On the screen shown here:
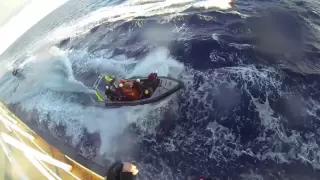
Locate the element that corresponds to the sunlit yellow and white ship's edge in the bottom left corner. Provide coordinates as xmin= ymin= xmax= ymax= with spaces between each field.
xmin=0 ymin=103 xmax=104 ymax=180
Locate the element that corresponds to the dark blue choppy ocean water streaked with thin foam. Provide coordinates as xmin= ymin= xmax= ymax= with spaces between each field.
xmin=1 ymin=0 xmax=320 ymax=180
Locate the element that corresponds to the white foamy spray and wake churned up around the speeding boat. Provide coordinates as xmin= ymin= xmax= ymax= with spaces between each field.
xmin=0 ymin=42 xmax=183 ymax=160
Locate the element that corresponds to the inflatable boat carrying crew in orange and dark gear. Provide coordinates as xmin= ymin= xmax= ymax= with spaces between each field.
xmin=93 ymin=73 xmax=184 ymax=107
